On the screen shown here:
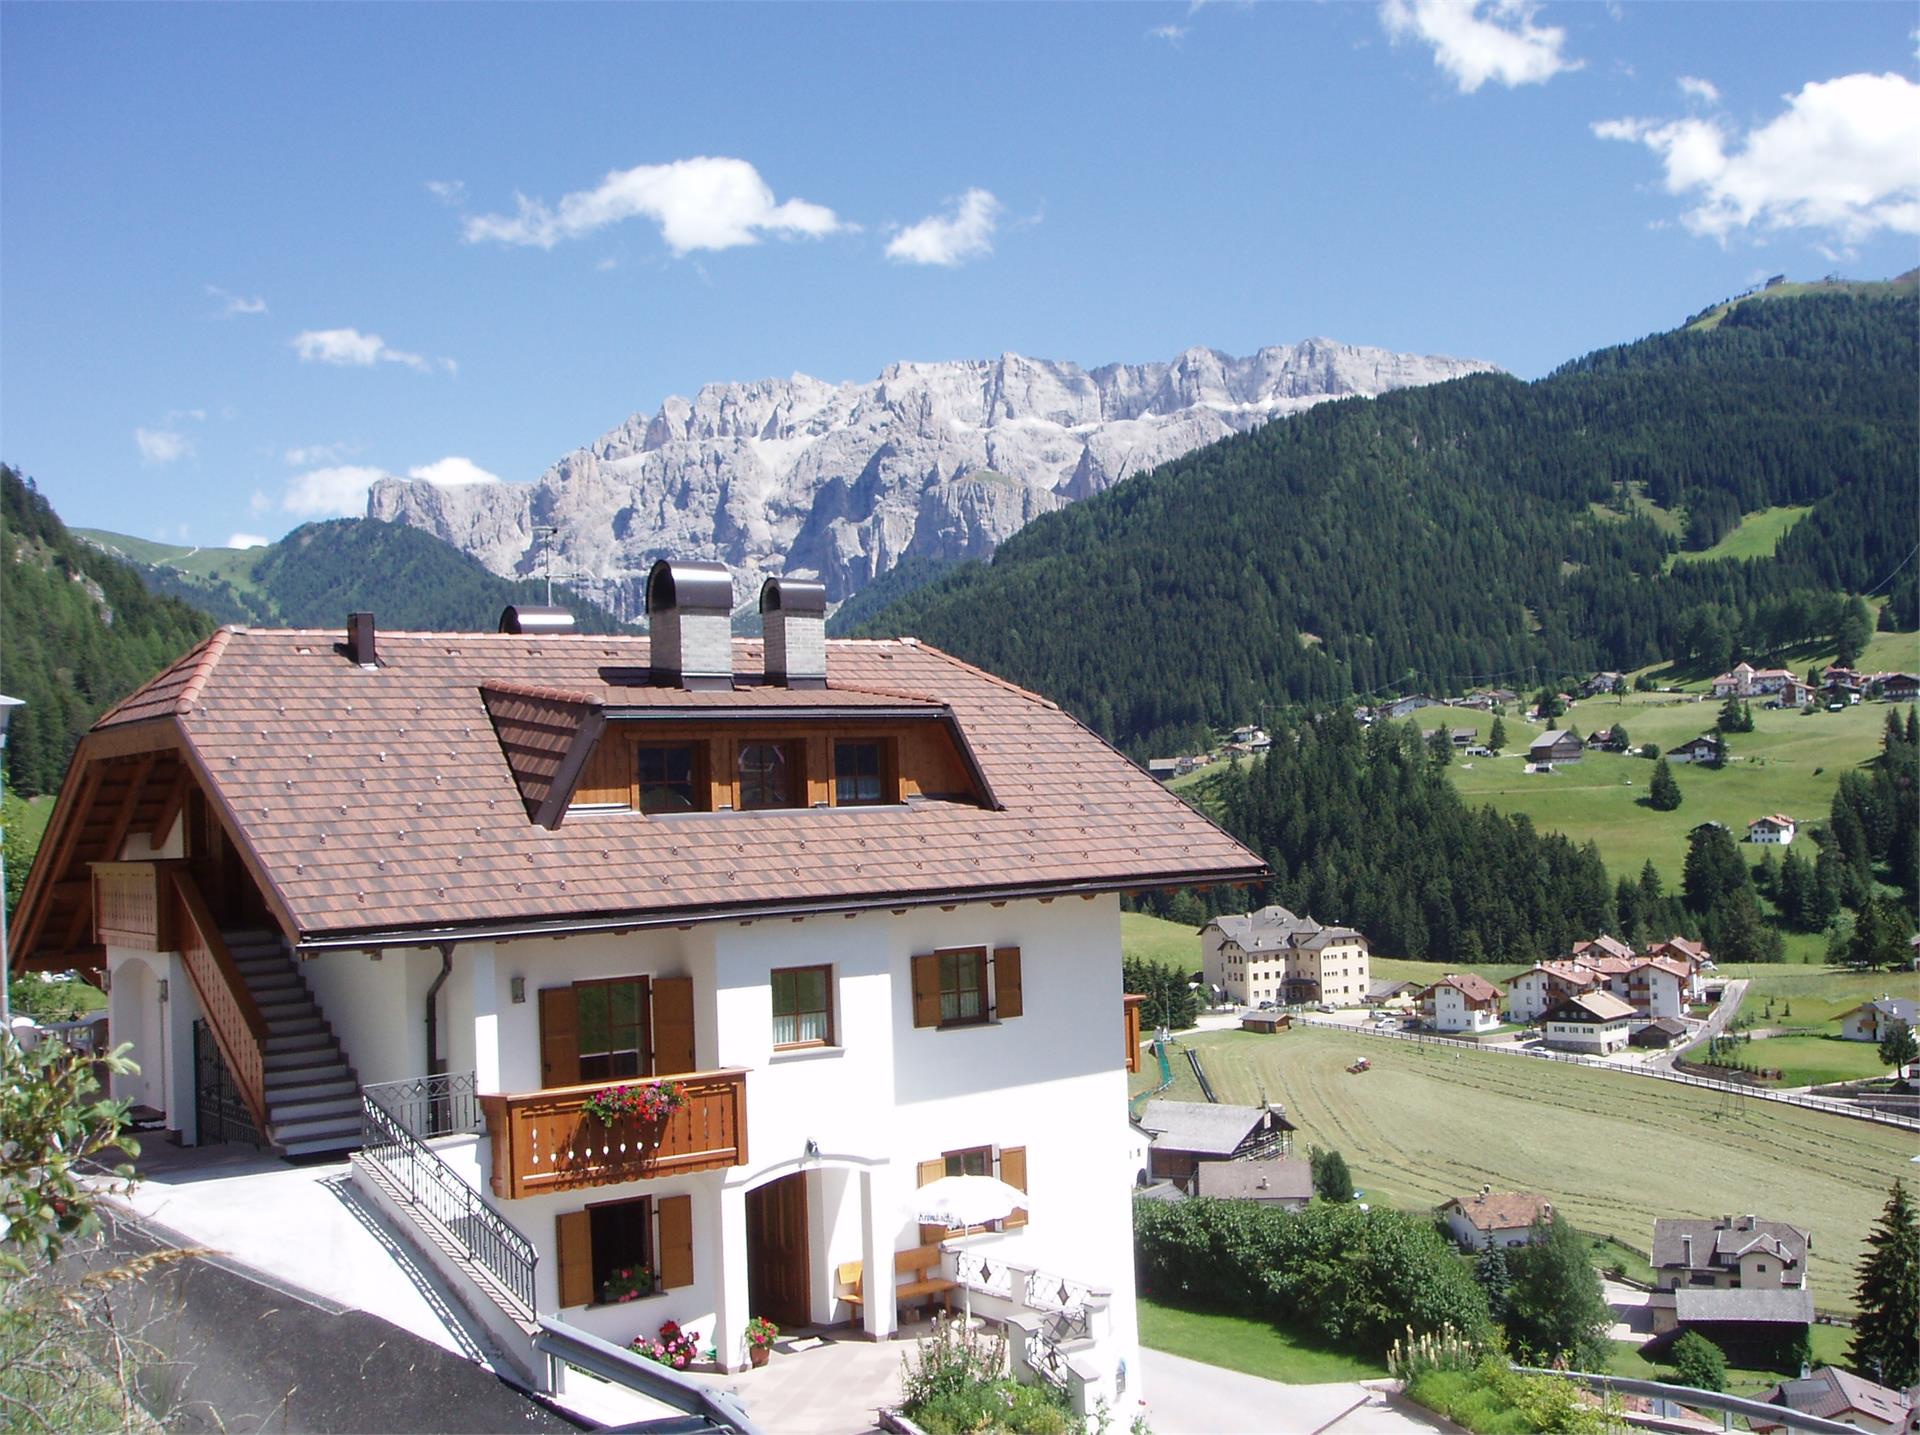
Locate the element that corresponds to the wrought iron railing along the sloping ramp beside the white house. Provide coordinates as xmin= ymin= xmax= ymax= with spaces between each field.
xmin=361 ymin=1074 xmax=538 ymax=1320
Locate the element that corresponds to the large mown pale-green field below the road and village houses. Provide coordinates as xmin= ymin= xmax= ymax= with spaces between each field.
xmin=1135 ymin=1028 xmax=1912 ymax=1310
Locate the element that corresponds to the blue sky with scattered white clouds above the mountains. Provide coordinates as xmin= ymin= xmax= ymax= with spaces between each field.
xmin=0 ymin=0 xmax=1920 ymax=544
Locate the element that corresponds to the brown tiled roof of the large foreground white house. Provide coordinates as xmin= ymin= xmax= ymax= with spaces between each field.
xmin=102 ymin=628 xmax=1263 ymax=941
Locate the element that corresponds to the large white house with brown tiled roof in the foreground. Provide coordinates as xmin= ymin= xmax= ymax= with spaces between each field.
xmin=15 ymin=561 xmax=1265 ymax=1406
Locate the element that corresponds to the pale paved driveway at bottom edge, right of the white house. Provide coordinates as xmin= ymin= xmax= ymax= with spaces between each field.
xmin=1136 ymin=1350 xmax=1457 ymax=1435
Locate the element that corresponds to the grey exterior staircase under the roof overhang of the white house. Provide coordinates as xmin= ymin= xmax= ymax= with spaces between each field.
xmin=223 ymin=930 xmax=361 ymax=1156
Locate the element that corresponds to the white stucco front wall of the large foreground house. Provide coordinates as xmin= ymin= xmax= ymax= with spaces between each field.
xmin=433 ymin=897 xmax=1139 ymax=1379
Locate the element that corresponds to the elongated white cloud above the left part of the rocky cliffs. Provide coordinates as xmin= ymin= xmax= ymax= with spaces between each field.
xmin=465 ymin=156 xmax=852 ymax=254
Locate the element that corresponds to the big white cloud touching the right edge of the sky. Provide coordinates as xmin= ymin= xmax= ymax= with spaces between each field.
xmin=1594 ymin=73 xmax=1920 ymax=244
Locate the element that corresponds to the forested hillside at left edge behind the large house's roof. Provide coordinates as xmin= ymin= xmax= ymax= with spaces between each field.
xmin=0 ymin=467 xmax=213 ymax=793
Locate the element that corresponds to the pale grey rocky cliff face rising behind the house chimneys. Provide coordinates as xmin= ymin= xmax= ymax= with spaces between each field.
xmin=367 ymin=347 xmax=1494 ymax=617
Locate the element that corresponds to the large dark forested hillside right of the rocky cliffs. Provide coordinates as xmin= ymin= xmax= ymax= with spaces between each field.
xmin=860 ymin=284 xmax=1920 ymax=755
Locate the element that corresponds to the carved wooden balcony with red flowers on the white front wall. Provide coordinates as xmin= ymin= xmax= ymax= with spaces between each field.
xmin=480 ymin=1070 xmax=747 ymax=1201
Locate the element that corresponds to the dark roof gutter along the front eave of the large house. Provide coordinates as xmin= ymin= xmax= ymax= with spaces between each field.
xmin=294 ymin=866 xmax=1273 ymax=957
